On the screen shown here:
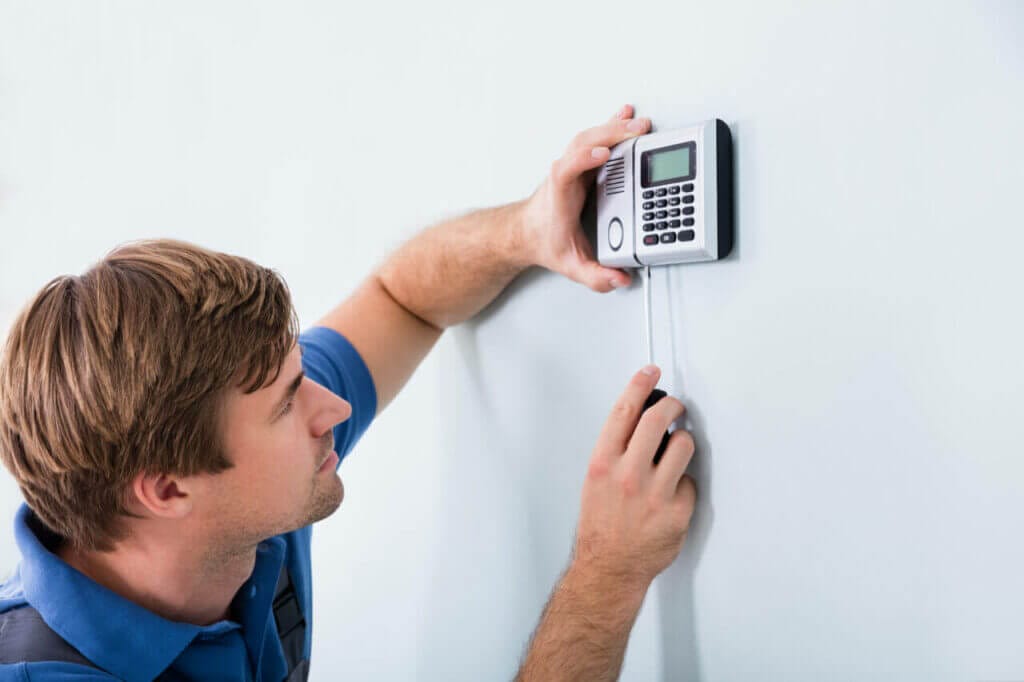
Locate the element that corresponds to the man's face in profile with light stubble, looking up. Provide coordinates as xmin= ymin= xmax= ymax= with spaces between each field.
xmin=203 ymin=345 xmax=352 ymax=545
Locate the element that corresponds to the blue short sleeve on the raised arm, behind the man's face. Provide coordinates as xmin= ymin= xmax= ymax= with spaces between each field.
xmin=299 ymin=327 xmax=377 ymax=464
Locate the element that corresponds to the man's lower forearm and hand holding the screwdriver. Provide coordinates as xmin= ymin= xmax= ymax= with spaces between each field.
xmin=516 ymin=367 xmax=696 ymax=682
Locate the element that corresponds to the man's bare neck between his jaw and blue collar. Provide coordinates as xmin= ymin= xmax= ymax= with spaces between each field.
xmin=57 ymin=522 xmax=256 ymax=626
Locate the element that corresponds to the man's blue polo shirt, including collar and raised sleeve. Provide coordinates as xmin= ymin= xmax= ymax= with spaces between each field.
xmin=0 ymin=327 xmax=377 ymax=682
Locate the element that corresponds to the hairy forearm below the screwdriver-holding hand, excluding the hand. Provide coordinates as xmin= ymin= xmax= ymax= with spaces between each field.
xmin=516 ymin=565 xmax=646 ymax=682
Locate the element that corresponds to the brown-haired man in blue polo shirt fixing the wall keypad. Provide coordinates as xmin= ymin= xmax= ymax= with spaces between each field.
xmin=0 ymin=105 xmax=695 ymax=681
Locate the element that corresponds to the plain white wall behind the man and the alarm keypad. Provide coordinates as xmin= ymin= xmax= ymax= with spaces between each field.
xmin=0 ymin=1 xmax=1024 ymax=680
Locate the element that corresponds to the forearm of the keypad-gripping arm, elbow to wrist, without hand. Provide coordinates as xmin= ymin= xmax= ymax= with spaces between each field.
xmin=377 ymin=197 xmax=531 ymax=329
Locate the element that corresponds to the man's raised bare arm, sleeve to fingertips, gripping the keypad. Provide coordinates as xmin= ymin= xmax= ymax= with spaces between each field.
xmin=318 ymin=105 xmax=650 ymax=412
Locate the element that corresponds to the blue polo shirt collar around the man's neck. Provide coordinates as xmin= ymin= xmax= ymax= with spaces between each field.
xmin=14 ymin=504 xmax=285 ymax=682
